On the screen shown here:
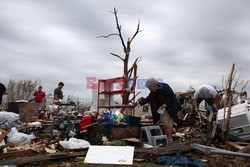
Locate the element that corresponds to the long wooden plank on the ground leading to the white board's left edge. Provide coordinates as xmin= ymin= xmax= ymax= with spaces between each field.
xmin=0 ymin=151 xmax=87 ymax=166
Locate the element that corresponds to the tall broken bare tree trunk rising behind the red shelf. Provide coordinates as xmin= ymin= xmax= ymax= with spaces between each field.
xmin=99 ymin=8 xmax=142 ymax=104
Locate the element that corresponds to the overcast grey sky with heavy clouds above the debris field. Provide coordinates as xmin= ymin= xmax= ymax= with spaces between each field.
xmin=0 ymin=0 xmax=250 ymax=99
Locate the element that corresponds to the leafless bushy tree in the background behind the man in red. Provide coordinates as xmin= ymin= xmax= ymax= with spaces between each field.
xmin=7 ymin=79 xmax=41 ymax=102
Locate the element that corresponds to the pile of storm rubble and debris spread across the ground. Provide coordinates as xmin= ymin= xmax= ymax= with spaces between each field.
xmin=0 ymin=99 xmax=250 ymax=166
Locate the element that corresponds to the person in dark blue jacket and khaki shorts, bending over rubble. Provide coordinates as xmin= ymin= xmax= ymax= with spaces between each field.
xmin=139 ymin=78 xmax=181 ymax=142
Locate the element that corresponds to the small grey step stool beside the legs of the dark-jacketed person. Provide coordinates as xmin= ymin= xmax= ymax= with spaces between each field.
xmin=141 ymin=125 xmax=168 ymax=146
